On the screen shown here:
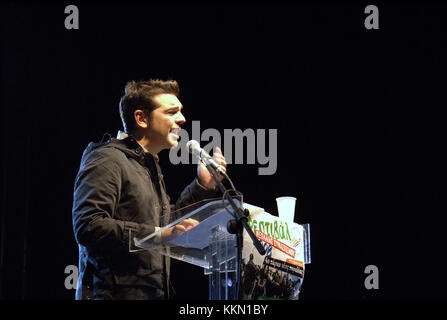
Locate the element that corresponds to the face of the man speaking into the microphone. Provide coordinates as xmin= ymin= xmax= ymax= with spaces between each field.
xmin=147 ymin=94 xmax=186 ymax=151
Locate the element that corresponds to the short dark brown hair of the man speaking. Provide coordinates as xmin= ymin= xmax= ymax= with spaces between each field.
xmin=119 ymin=79 xmax=180 ymax=134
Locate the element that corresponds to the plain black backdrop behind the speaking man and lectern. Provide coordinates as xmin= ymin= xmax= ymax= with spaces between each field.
xmin=0 ymin=1 xmax=447 ymax=300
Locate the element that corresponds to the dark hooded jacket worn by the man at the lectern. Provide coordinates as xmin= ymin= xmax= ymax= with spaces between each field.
xmin=72 ymin=135 xmax=215 ymax=299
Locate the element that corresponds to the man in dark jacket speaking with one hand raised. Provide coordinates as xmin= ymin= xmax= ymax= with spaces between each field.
xmin=72 ymin=79 xmax=226 ymax=300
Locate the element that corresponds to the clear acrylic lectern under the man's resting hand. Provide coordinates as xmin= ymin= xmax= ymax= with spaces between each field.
xmin=131 ymin=198 xmax=240 ymax=300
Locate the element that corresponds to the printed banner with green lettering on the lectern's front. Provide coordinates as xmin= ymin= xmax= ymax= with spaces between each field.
xmin=239 ymin=204 xmax=306 ymax=300
